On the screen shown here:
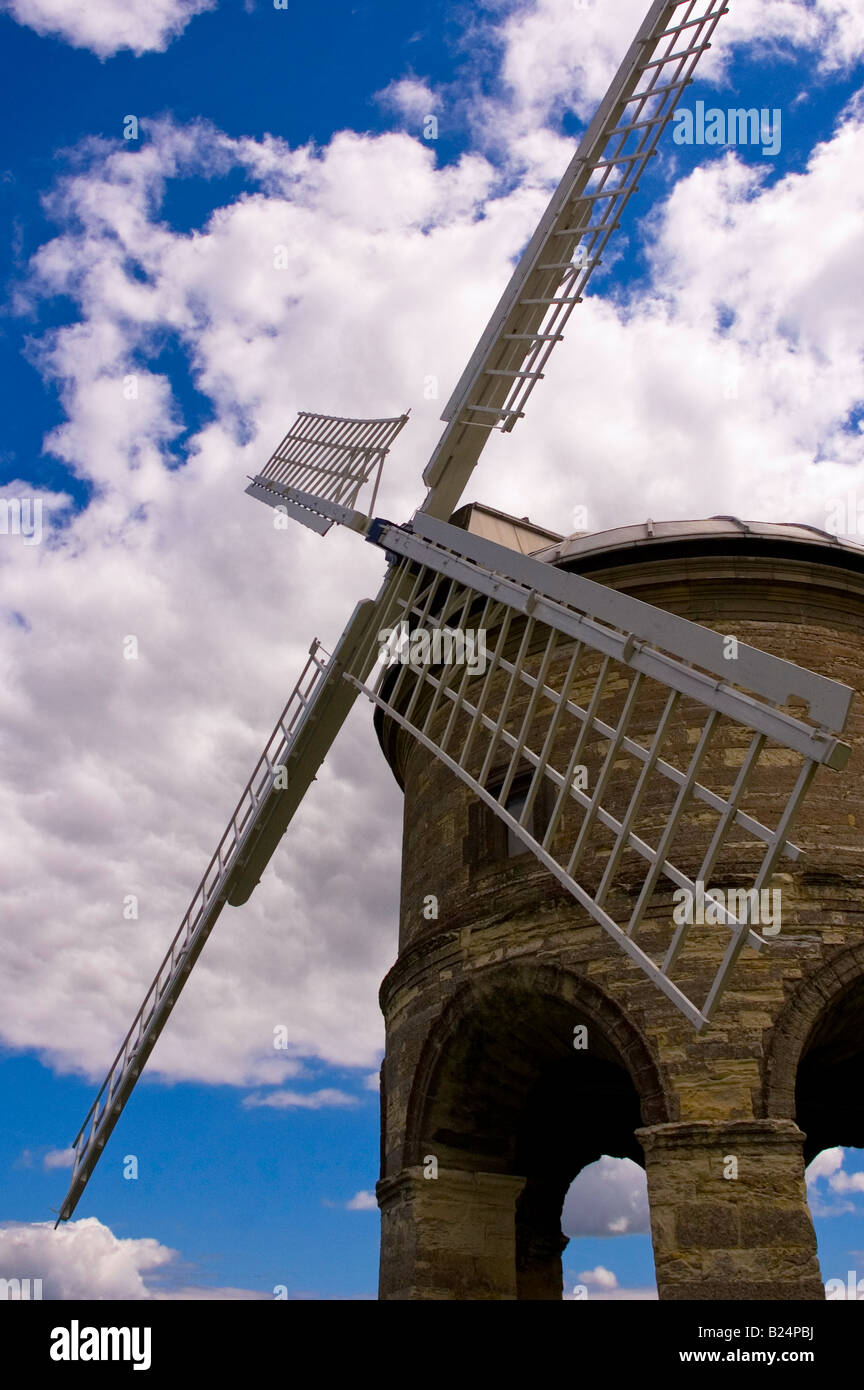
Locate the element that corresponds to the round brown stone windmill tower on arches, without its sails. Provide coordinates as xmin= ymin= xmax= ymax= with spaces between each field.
xmin=378 ymin=507 xmax=864 ymax=1300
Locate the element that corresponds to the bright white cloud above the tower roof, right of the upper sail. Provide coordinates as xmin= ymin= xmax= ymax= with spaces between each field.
xmin=488 ymin=92 xmax=864 ymax=530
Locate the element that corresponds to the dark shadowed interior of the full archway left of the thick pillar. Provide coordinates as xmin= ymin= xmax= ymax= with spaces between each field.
xmin=404 ymin=962 xmax=676 ymax=1298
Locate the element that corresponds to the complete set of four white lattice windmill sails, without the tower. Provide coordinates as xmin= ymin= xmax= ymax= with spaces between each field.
xmin=58 ymin=0 xmax=851 ymax=1222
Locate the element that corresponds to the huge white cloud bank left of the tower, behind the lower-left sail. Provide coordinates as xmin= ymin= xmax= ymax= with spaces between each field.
xmin=0 ymin=113 xmax=513 ymax=1106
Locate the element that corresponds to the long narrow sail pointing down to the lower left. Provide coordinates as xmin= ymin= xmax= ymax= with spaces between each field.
xmin=58 ymin=599 xmax=378 ymax=1222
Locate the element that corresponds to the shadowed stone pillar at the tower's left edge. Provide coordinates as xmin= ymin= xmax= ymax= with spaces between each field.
xmin=376 ymin=1166 xmax=525 ymax=1300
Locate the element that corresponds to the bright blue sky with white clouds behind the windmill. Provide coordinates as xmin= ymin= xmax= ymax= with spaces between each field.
xmin=0 ymin=0 xmax=864 ymax=1298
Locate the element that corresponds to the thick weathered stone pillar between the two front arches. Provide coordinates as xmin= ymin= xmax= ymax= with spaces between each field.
xmin=636 ymin=1120 xmax=825 ymax=1301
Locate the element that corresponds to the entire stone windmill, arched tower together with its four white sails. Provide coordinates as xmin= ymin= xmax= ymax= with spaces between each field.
xmin=60 ymin=0 xmax=864 ymax=1300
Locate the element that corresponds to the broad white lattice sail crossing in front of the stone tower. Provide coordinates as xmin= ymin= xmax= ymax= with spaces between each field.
xmin=347 ymin=514 xmax=851 ymax=1029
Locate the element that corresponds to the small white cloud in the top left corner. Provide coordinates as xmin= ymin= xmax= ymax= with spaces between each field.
xmin=1 ymin=0 xmax=217 ymax=58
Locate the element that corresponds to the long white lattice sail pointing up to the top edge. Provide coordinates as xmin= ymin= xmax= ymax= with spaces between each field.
xmin=422 ymin=0 xmax=728 ymax=520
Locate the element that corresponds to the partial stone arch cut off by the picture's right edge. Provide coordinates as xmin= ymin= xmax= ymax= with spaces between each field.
xmin=763 ymin=942 xmax=864 ymax=1162
